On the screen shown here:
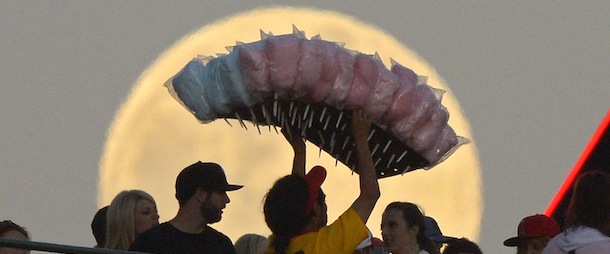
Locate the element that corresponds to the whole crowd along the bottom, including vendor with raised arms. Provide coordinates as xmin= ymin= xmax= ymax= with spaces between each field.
xmin=0 ymin=110 xmax=610 ymax=254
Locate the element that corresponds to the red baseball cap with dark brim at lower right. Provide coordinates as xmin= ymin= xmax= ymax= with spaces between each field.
xmin=504 ymin=214 xmax=561 ymax=247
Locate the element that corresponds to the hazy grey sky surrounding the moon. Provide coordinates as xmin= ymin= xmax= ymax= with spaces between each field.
xmin=0 ymin=1 xmax=610 ymax=253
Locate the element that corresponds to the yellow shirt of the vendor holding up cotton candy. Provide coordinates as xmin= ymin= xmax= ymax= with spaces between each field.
xmin=267 ymin=208 xmax=368 ymax=254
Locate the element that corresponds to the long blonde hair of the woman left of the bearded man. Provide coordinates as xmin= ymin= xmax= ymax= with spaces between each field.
xmin=104 ymin=190 xmax=155 ymax=250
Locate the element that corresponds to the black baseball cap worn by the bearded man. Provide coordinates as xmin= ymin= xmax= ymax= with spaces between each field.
xmin=176 ymin=161 xmax=244 ymax=201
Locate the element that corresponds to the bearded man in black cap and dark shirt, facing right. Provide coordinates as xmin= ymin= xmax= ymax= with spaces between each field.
xmin=129 ymin=161 xmax=243 ymax=254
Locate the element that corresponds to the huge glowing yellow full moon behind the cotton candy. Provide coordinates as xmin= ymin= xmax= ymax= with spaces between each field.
xmin=98 ymin=7 xmax=483 ymax=241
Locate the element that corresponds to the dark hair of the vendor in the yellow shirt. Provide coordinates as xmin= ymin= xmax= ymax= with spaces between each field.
xmin=263 ymin=175 xmax=324 ymax=254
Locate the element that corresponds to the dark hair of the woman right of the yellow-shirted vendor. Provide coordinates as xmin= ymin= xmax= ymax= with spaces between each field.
xmin=384 ymin=202 xmax=439 ymax=254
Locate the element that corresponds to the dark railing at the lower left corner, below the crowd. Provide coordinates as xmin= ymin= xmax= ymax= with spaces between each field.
xmin=0 ymin=237 xmax=143 ymax=254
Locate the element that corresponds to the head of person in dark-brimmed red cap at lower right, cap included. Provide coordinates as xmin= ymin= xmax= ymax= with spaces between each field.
xmin=504 ymin=214 xmax=560 ymax=254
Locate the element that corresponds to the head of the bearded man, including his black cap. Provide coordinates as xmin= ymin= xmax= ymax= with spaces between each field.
xmin=176 ymin=161 xmax=243 ymax=224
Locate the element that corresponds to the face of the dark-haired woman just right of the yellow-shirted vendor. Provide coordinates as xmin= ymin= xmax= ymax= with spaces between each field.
xmin=381 ymin=209 xmax=419 ymax=253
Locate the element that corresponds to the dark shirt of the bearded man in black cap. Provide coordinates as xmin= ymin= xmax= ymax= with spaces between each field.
xmin=129 ymin=222 xmax=236 ymax=254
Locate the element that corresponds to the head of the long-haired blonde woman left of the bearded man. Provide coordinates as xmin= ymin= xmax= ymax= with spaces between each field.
xmin=104 ymin=190 xmax=159 ymax=250
